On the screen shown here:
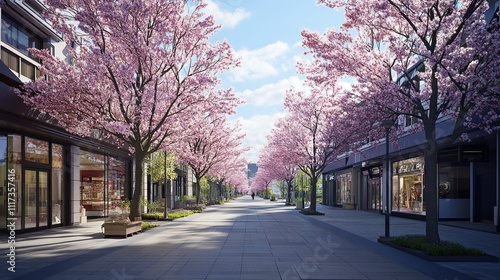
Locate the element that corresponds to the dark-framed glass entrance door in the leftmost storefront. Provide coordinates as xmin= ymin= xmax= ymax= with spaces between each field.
xmin=24 ymin=170 xmax=50 ymax=228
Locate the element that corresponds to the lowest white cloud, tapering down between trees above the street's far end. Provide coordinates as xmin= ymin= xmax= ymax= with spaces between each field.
xmin=231 ymin=113 xmax=283 ymax=162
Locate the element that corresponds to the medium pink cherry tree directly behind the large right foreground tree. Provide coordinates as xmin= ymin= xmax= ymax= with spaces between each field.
xmin=281 ymin=88 xmax=366 ymax=211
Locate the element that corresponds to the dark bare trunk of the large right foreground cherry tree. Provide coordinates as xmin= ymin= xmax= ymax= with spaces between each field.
xmin=424 ymin=137 xmax=440 ymax=243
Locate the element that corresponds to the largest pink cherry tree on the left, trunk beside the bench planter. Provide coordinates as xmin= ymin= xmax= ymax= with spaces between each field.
xmin=17 ymin=0 xmax=238 ymax=220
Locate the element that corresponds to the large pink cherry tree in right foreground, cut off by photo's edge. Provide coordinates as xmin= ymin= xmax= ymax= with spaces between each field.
xmin=299 ymin=0 xmax=500 ymax=242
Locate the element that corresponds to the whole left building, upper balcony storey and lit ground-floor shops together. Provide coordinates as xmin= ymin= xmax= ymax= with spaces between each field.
xmin=0 ymin=0 xmax=139 ymax=232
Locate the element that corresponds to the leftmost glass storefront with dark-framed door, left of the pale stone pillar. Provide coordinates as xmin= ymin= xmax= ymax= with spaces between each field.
xmin=0 ymin=134 xmax=66 ymax=230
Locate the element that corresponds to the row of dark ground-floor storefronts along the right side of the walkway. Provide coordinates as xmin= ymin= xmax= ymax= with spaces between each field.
xmin=323 ymin=119 xmax=500 ymax=229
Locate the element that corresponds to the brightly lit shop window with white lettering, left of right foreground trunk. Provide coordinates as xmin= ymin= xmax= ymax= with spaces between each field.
xmin=392 ymin=157 xmax=425 ymax=215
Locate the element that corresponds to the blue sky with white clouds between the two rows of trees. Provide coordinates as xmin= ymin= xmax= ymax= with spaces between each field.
xmin=201 ymin=0 xmax=344 ymax=163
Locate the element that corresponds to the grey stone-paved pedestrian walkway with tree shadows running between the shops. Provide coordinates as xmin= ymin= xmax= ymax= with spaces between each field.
xmin=0 ymin=196 xmax=500 ymax=280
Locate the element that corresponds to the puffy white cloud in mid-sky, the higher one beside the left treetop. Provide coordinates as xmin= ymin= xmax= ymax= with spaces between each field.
xmin=227 ymin=41 xmax=290 ymax=82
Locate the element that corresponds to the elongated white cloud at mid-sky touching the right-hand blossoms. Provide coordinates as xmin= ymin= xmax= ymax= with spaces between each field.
xmin=236 ymin=76 xmax=303 ymax=106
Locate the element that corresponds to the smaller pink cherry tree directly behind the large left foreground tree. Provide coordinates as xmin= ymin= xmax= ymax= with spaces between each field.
xmin=176 ymin=114 xmax=245 ymax=204
